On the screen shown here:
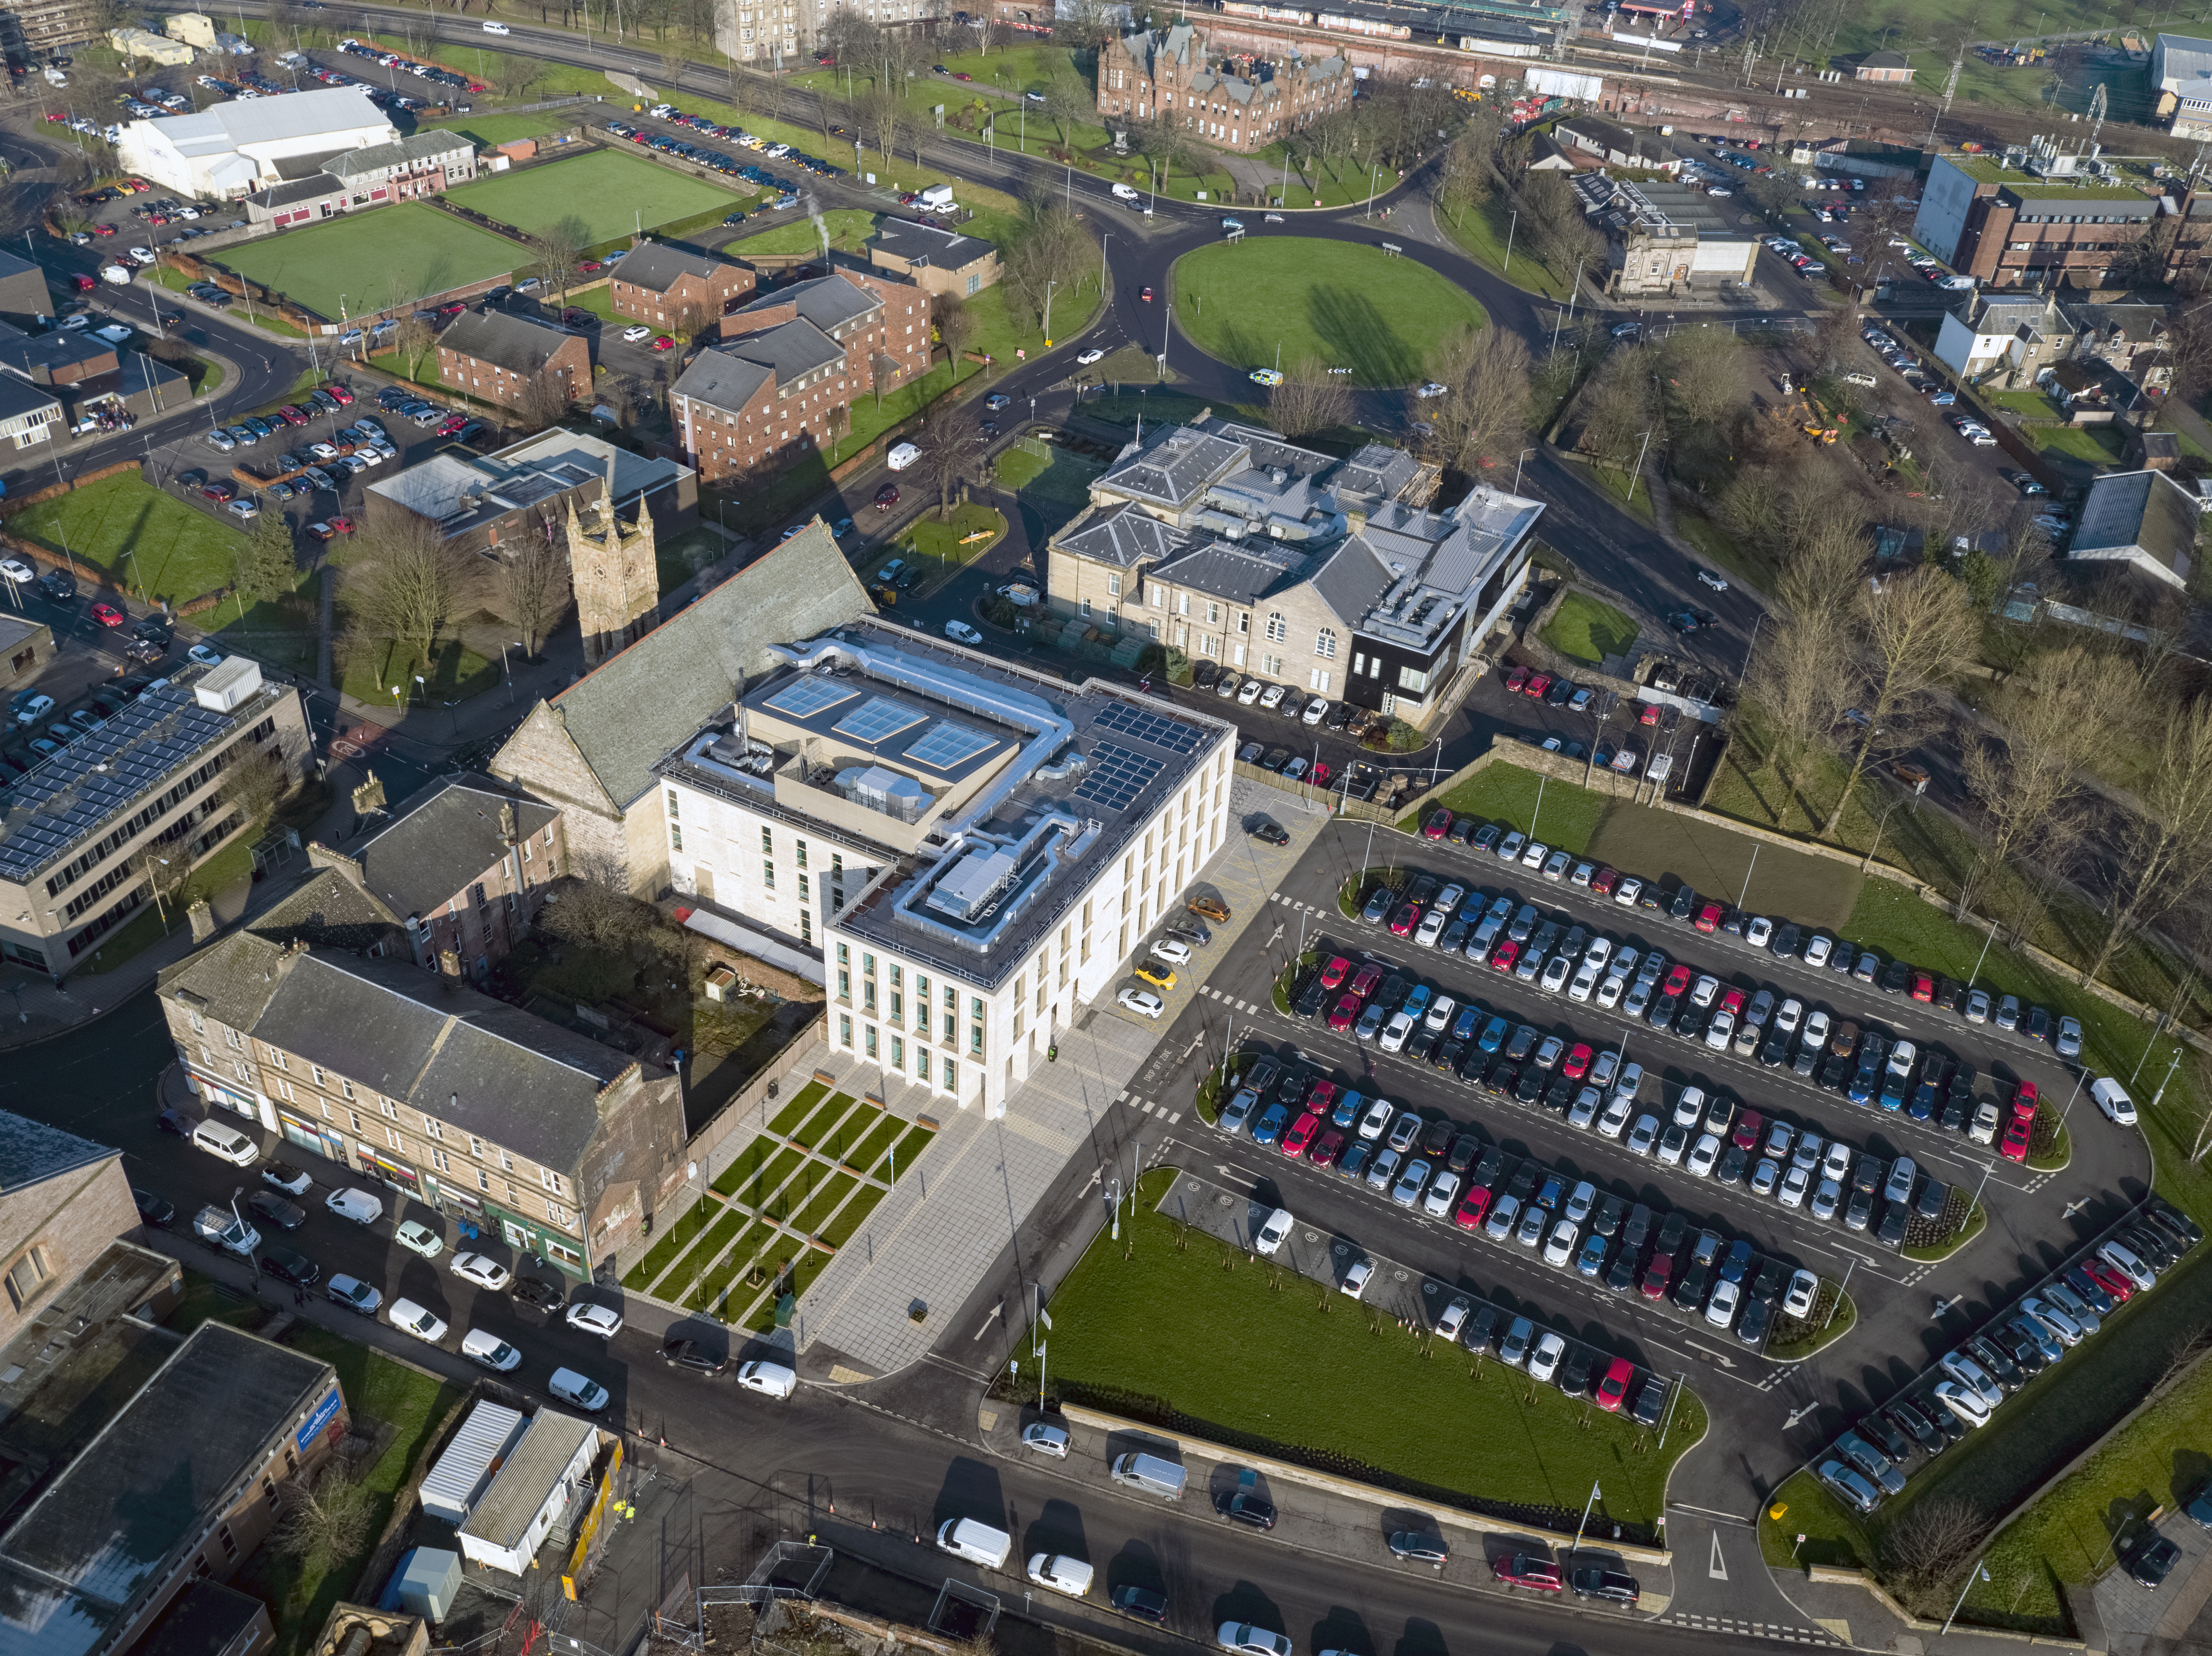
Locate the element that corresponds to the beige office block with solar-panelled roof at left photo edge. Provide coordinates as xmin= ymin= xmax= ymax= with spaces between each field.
xmin=0 ymin=656 xmax=312 ymax=975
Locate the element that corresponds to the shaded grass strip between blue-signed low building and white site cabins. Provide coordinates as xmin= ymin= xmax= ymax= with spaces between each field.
xmin=232 ymin=1324 xmax=467 ymax=1651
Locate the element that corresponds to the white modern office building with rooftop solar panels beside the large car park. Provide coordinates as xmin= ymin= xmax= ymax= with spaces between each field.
xmin=655 ymin=617 xmax=1236 ymax=1117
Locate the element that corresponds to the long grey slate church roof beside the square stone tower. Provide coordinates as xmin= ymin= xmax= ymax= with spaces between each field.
xmin=526 ymin=517 xmax=874 ymax=807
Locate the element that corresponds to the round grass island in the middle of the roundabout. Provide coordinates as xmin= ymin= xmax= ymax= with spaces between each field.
xmin=1174 ymin=239 xmax=1484 ymax=385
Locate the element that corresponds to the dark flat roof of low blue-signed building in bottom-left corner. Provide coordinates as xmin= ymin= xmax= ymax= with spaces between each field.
xmin=0 ymin=1322 xmax=339 ymax=1656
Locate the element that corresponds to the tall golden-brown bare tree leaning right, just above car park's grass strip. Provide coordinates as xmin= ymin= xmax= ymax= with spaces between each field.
xmin=1821 ymin=568 xmax=1982 ymax=838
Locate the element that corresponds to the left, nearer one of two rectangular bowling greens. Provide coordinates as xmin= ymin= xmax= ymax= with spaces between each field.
xmin=210 ymin=202 xmax=535 ymax=320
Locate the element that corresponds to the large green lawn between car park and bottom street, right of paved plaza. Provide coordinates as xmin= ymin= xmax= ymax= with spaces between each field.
xmin=1035 ymin=1169 xmax=1703 ymax=1534
